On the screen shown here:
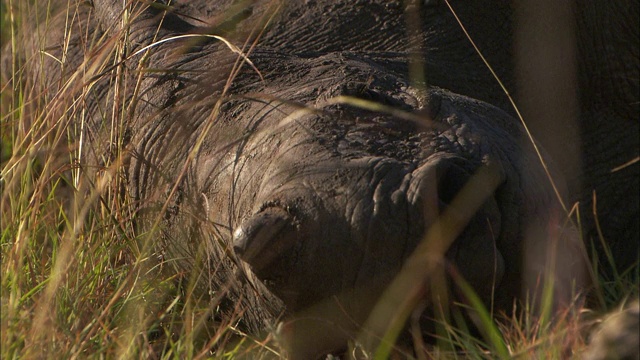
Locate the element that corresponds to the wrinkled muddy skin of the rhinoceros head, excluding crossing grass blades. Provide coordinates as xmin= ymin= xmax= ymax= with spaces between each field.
xmin=30 ymin=0 xmax=637 ymax=357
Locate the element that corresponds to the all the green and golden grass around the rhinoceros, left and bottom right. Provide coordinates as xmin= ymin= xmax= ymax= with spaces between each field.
xmin=0 ymin=0 xmax=638 ymax=359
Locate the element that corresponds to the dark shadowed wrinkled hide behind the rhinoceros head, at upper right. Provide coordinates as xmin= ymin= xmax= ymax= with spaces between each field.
xmin=170 ymin=0 xmax=640 ymax=271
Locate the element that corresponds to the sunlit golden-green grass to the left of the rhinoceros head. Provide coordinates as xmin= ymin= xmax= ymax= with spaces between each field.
xmin=0 ymin=1 xmax=277 ymax=359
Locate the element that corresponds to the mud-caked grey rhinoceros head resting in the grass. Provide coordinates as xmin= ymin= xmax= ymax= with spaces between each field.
xmin=30 ymin=0 xmax=592 ymax=356
